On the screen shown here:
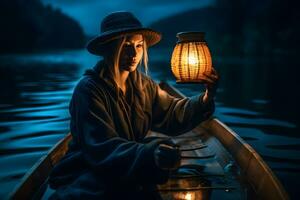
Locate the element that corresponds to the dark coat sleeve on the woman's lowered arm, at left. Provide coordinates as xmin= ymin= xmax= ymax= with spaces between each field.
xmin=70 ymin=79 xmax=168 ymax=184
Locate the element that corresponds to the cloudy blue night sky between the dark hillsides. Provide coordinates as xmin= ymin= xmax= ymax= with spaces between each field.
xmin=42 ymin=0 xmax=214 ymax=35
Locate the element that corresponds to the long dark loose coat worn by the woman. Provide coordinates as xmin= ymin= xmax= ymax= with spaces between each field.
xmin=49 ymin=62 xmax=214 ymax=199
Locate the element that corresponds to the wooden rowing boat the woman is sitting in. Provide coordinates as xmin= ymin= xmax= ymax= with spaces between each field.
xmin=9 ymin=83 xmax=289 ymax=200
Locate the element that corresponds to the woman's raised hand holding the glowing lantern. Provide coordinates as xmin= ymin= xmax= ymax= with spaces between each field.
xmin=203 ymin=68 xmax=219 ymax=103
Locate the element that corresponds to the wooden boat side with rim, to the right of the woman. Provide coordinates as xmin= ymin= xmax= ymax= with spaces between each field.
xmin=200 ymin=118 xmax=289 ymax=199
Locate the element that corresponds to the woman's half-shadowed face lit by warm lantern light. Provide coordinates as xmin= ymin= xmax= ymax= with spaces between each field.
xmin=119 ymin=34 xmax=144 ymax=72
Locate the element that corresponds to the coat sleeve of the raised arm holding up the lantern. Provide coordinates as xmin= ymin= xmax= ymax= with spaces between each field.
xmin=152 ymin=83 xmax=215 ymax=136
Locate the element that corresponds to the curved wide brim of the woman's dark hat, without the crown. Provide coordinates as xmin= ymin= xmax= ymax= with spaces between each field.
xmin=86 ymin=28 xmax=161 ymax=56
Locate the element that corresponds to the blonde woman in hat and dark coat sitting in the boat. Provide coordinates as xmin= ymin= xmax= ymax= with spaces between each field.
xmin=50 ymin=12 xmax=218 ymax=199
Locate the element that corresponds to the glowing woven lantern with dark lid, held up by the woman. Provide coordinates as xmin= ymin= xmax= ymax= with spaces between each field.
xmin=171 ymin=32 xmax=212 ymax=83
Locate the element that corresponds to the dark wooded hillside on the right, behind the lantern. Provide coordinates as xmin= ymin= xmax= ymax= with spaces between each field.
xmin=152 ymin=0 xmax=300 ymax=56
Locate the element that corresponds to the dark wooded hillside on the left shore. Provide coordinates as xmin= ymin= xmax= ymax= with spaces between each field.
xmin=0 ymin=0 xmax=85 ymax=53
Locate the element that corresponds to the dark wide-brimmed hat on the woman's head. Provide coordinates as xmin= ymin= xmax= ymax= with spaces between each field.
xmin=86 ymin=11 xmax=161 ymax=55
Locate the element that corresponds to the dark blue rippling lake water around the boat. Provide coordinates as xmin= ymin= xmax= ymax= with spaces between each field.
xmin=0 ymin=50 xmax=300 ymax=199
